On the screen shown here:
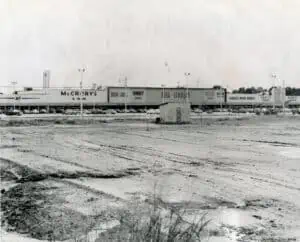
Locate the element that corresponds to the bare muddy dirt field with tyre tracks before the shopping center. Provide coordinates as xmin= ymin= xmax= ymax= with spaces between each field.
xmin=0 ymin=117 xmax=300 ymax=242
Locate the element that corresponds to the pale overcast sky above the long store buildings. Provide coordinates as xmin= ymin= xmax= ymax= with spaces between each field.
xmin=0 ymin=0 xmax=300 ymax=88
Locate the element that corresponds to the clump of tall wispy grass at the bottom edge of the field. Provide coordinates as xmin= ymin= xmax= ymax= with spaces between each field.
xmin=96 ymin=200 xmax=209 ymax=242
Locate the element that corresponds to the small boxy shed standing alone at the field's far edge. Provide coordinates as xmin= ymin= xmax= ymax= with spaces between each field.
xmin=159 ymin=102 xmax=191 ymax=124
